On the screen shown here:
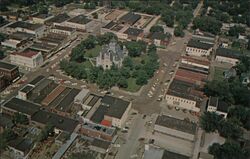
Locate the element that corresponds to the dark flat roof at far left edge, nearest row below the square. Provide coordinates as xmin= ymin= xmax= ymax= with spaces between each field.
xmin=3 ymin=97 xmax=41 ymax=115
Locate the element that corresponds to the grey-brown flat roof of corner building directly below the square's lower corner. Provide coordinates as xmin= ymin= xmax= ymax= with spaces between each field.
xmin=101 ymin=95 xmax=130 ymax=119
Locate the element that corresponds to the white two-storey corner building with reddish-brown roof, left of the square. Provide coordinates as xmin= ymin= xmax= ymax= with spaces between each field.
xmin=10 ymin=50 xmax=43 ymax=70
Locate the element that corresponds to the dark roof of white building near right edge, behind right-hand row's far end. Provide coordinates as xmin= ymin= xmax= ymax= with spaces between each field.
xmin=216 ymin=47 xmax=242 ymax=59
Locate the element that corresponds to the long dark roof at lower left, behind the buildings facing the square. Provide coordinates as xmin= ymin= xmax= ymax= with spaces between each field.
xmin=31 ymin=110 xmax=79 ymax=132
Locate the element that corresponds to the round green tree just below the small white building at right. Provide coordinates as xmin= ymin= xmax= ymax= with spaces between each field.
xmin=200 ymin=112 xmax=223 ymax=133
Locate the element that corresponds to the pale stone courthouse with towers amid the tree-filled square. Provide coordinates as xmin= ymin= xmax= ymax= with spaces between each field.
xmin=96 ymin=39 xmax=128 ymax=69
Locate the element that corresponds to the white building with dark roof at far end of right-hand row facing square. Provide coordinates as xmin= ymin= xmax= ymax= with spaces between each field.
xmin=186 ymin=40 xmax=213 ymax=56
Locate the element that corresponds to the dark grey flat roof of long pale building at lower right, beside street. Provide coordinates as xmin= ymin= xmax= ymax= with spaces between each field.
xmin=155 ymin=115 xmax=197 ymax=135
